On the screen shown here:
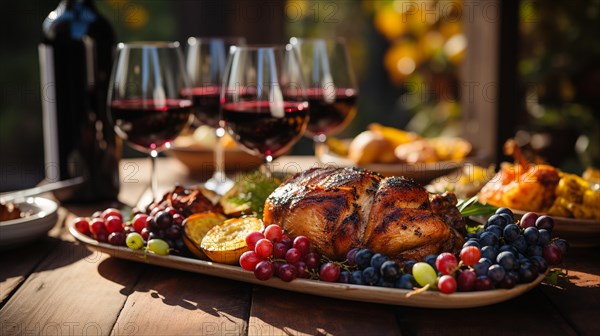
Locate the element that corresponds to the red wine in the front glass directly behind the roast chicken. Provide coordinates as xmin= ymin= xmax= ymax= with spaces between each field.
xmin=222 ymin=101 xmax=308 ymax=157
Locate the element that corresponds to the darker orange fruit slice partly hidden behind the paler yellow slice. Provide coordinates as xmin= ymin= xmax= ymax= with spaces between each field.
xmin=183 ymin=212 xmax=227 ymax=260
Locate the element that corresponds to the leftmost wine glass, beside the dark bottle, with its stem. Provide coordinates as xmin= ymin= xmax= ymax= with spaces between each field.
xmin=108 ymin=42 xmax=192 ymax=200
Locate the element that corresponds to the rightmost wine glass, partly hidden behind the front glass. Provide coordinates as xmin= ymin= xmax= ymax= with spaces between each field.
xmin=290 ymin=37 xmax=358 ymax=157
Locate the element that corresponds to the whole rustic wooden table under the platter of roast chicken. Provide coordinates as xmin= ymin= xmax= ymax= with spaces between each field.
xmin=0 ymin=157 xmax=600 ymax=335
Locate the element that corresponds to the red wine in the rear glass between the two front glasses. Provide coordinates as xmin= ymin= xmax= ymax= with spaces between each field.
xmin=189 ymin=86 xmax=221 ymax=128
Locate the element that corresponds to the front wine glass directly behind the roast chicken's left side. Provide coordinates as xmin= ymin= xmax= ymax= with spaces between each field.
xmin=221 ymin=45 xmax=309 ymax=176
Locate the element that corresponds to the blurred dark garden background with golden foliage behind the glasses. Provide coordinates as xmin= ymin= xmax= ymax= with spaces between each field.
xmin=0 ymin=0 xmax=600 ymax=191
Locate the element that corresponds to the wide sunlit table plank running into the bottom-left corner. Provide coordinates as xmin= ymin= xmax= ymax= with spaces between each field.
xmin=0 ymin=241 xmax=140 ymax=335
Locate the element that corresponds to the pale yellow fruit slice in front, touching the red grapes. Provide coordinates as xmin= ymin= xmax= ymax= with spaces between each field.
xmin=200 ymin=217 xmax=264 ymax=265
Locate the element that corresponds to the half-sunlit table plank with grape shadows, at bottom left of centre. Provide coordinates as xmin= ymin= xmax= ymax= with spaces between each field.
xmin=112 ymin=265 xmax=251 ymax=335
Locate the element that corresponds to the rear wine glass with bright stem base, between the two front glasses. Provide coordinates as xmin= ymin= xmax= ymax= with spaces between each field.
xmin=186 ymin=37 xmax=246 ymax=194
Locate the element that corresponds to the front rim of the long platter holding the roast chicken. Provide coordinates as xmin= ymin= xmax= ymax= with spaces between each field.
xmin=68 ymin=223 xmax=544 ymax=309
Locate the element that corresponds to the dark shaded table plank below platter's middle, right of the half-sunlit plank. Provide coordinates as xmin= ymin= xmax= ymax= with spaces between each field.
xmin=248 ymin=286 xmax=400 ymax=336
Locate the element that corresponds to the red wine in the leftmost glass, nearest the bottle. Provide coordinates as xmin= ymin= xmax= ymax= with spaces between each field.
xmin=110 ymin=99 xmax=192 ymax=152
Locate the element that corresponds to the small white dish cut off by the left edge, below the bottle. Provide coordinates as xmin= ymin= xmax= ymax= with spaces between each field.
xmin=0 ymin=197 xmax=58 ymax=249
